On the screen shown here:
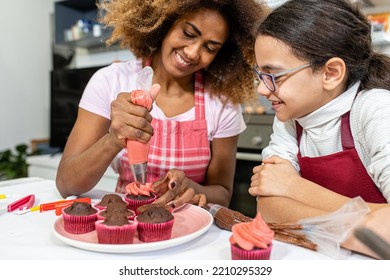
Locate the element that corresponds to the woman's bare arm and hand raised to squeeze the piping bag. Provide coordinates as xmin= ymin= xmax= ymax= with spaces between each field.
xmin=56 ymin=87 xmax=155 ymax=197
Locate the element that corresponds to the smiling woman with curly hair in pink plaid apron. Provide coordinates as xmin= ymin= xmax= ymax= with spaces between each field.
xmin=56 ymin=0 xmax=268 ymax=206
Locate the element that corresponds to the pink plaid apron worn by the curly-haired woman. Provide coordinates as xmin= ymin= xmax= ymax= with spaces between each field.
xmin=116 ymin=72 xmax=211 ymax=193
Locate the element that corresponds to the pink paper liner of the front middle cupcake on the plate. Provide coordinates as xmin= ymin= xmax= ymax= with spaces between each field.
xmin=95 ymin=220 xmax=137 ymax=244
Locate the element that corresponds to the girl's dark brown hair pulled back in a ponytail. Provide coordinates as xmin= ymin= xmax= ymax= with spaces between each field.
xmin=255 ymin=0 xmax=390 ymax=90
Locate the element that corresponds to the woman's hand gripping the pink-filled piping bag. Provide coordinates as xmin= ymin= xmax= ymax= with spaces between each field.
xmin=109 ymin=84 xmax=160 ymax=148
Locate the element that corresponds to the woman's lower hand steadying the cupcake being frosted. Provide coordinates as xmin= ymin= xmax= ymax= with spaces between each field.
xmin=152 ymin=169 xmax=207 ymax=207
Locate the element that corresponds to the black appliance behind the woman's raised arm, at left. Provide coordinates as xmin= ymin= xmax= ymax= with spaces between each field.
xmin=50 ymin=66 xmax=103 ymax=152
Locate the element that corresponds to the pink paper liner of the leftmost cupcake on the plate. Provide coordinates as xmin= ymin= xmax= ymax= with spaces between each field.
xmin=62 ymin=208 xmax=97 ymax=234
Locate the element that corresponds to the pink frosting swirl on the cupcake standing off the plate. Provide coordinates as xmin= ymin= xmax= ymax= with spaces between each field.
xmin=229 ymin=213 xmax=275 ymax=251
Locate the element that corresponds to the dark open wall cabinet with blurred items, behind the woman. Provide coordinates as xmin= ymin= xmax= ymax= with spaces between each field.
xmin=54 ymin=0 xmax=110 ymax=48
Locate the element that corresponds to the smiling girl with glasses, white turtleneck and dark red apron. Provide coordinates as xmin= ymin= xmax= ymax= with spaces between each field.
xmin=249 ymin=0 xmax=390 ymax=255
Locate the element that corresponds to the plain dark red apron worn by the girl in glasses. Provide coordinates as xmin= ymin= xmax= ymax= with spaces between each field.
xmin=296 ymin=112 xmax=387 ymax=203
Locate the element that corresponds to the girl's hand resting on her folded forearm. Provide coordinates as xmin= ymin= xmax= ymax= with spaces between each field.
xmin=249 ymin=156 xmax=301 ymax=197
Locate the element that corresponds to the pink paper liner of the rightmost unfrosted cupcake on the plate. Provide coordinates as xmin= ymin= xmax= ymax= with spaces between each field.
xmin=134 ymin=217 xmax=175 ymax=242
